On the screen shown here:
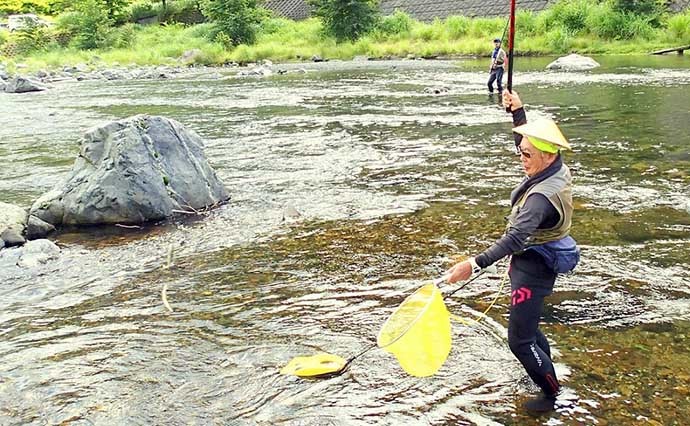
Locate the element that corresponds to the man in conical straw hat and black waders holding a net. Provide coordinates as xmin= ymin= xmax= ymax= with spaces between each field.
xmin=448 ymin=90 xmax=579 ymax=412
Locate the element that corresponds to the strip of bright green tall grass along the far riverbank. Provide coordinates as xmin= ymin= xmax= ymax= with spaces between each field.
xmin=5 ymin=0 xmax=690 ymax=68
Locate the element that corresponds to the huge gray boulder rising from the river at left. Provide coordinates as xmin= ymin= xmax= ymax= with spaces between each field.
xmin=30 ymin=115 xmax=229 ymax=225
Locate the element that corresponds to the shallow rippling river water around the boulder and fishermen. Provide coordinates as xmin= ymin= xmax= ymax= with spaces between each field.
xmin=0 ymin=56 xmax=690 ymax=425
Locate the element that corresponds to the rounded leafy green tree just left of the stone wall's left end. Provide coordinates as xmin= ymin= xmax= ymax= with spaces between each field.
xmin=202 ymin=0 xmax=266 ymax=45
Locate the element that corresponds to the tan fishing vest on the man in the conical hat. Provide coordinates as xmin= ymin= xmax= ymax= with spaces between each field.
xmin=506 ymin=164 xmax=573 ymax=247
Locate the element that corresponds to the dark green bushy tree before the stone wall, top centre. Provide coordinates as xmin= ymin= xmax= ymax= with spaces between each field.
xmin=308 ymin=0 xmax=379 ymax=41
